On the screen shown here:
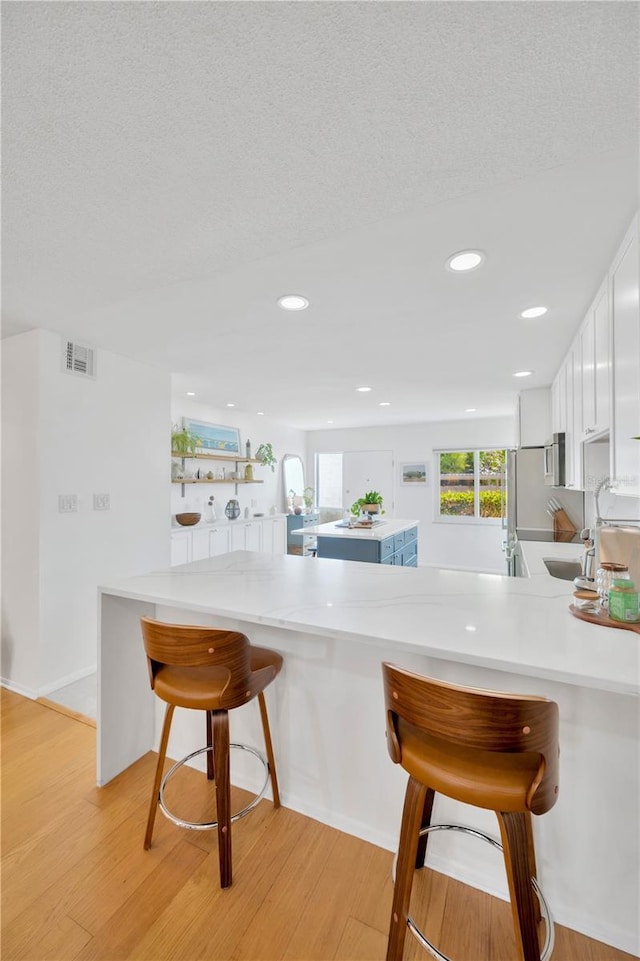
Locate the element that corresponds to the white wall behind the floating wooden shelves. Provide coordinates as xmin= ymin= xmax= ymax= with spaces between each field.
xmin=170 ymin=391 xmax=304 ymax=517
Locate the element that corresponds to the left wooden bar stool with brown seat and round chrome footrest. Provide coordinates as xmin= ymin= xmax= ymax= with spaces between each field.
xmin=141 ymin=617 xmax=282 ymax=888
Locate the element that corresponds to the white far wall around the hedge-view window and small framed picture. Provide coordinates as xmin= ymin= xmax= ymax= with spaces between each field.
xmin=307 ymin=417 xmax=515 ymax=574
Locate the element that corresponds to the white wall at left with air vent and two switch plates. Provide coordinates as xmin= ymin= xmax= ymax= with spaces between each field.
xmin=2 ymin=330 xmax=170 ymax=696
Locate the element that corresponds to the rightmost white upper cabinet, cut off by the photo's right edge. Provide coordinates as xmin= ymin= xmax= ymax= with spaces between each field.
xmin=610 ymin=216 xmax=640 ymax=496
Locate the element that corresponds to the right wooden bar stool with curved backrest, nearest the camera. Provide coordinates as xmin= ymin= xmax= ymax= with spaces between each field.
xmin=382 ymin=663 xmax=558 ymax=961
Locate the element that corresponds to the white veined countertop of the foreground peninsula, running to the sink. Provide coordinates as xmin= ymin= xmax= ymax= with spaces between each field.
xmin=101 ymin=544 xmax=640 ymax=695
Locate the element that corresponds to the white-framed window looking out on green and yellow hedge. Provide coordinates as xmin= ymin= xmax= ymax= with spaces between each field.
xmin=436 ymin=450 xmax=506 ymax=522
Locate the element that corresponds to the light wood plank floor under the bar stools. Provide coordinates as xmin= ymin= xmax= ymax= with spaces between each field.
xmin=0 ymin=691 xmax=631 ymax=961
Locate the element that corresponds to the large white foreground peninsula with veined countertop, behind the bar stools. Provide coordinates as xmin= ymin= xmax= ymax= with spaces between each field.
xmin=97 ymin=552 xmax=640 ymax=952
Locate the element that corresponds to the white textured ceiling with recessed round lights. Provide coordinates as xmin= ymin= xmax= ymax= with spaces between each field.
xmin=2 ymin=0 xmax=639 ymax=429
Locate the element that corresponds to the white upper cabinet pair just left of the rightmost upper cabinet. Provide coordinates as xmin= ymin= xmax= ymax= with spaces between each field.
xmin=579 ymin=281 xmax=611 ymax=440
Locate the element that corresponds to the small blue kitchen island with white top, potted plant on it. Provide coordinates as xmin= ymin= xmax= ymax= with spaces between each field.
xmin=291 ymin=517 xmax=419 ymax=567
